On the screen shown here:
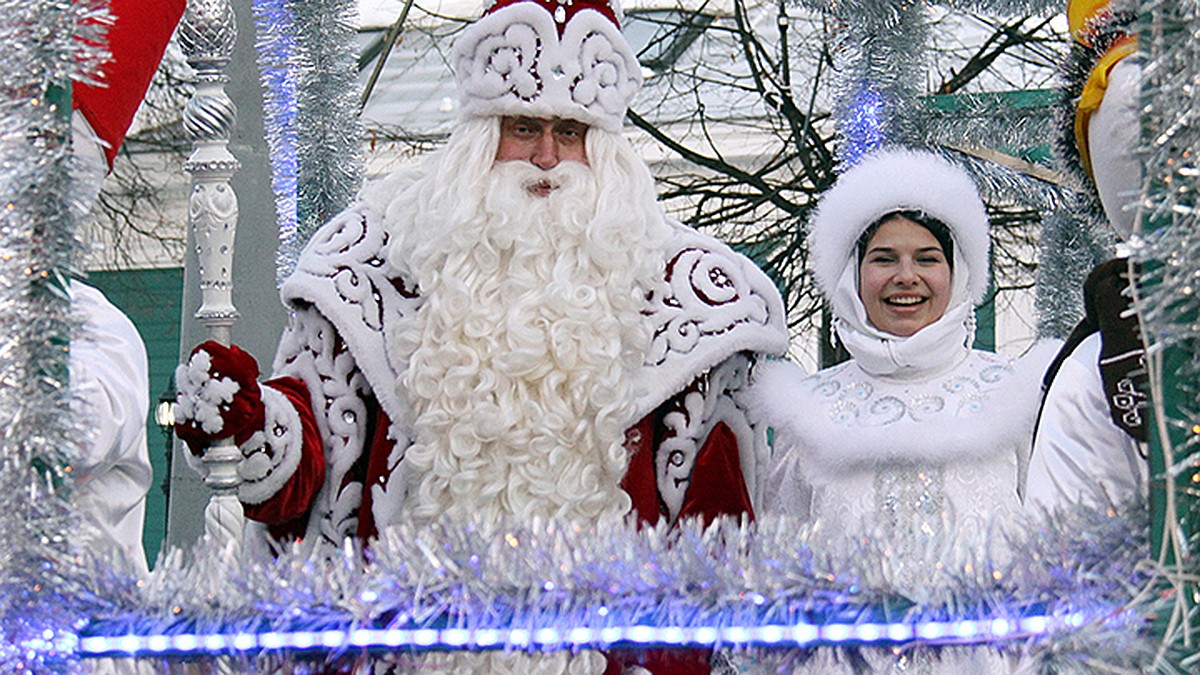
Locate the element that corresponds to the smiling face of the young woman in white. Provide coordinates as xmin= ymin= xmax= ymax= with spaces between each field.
xmin=858 ymin=216 xmax=950 ymax=338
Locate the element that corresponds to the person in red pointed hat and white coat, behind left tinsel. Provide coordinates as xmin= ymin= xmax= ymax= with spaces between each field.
xmin=67 ymin=0 xmax=186 ymax=576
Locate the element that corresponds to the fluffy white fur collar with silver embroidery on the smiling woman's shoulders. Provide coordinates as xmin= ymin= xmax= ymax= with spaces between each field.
xmin=745 ymin=345 xmax=1052 ymax=480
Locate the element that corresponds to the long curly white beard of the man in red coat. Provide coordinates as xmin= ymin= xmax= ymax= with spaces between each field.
xmin=396 ymin=162 xmax=661 ymax=521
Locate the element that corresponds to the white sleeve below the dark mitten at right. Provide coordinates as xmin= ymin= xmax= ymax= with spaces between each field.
xmin=1025 ymin=334 xmax=1148 ymax=512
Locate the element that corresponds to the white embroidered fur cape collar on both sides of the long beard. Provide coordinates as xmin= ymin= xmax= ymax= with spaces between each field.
xmin=282 ymin=199 xmax=788 ymax=434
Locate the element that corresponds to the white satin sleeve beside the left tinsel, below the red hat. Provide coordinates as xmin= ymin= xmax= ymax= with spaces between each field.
xmin=70 ymin=282 xmax=152 ymax=571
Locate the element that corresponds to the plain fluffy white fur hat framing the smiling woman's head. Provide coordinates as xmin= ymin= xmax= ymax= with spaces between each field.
xmin=809 ymin=150 xmax=990 ymax=305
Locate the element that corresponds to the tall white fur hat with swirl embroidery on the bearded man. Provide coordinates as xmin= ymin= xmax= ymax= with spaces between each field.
xmin=452 ymin=0 xmax=642 ymax=131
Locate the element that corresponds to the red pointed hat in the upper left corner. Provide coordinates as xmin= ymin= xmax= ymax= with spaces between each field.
xmin=71 ymin=0 xmax=187 ymax=169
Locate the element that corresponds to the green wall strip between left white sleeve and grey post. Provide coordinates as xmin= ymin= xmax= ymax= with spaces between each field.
xmin=85 ymin=268 xmax=184 ymax=565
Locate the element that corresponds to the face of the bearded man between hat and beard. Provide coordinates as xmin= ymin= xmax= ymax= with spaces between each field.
xmin=496 ymin=117 xmax=588 ymax=197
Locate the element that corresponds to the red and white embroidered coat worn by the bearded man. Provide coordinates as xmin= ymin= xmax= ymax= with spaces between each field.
xmin=212 ymin=192 xmax=787 ymax=545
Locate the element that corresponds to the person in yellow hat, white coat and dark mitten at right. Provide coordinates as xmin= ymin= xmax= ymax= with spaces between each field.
xmin=1024 ymin=0 xmax=1150 ymax=514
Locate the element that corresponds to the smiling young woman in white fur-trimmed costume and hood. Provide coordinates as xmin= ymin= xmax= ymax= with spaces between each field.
xmin=750 ymin=150 xmax=1045 ymax=673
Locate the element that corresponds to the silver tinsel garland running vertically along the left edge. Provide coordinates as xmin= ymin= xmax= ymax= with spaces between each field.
xmin=0 ymin=0 xmax=108 ymax=673
